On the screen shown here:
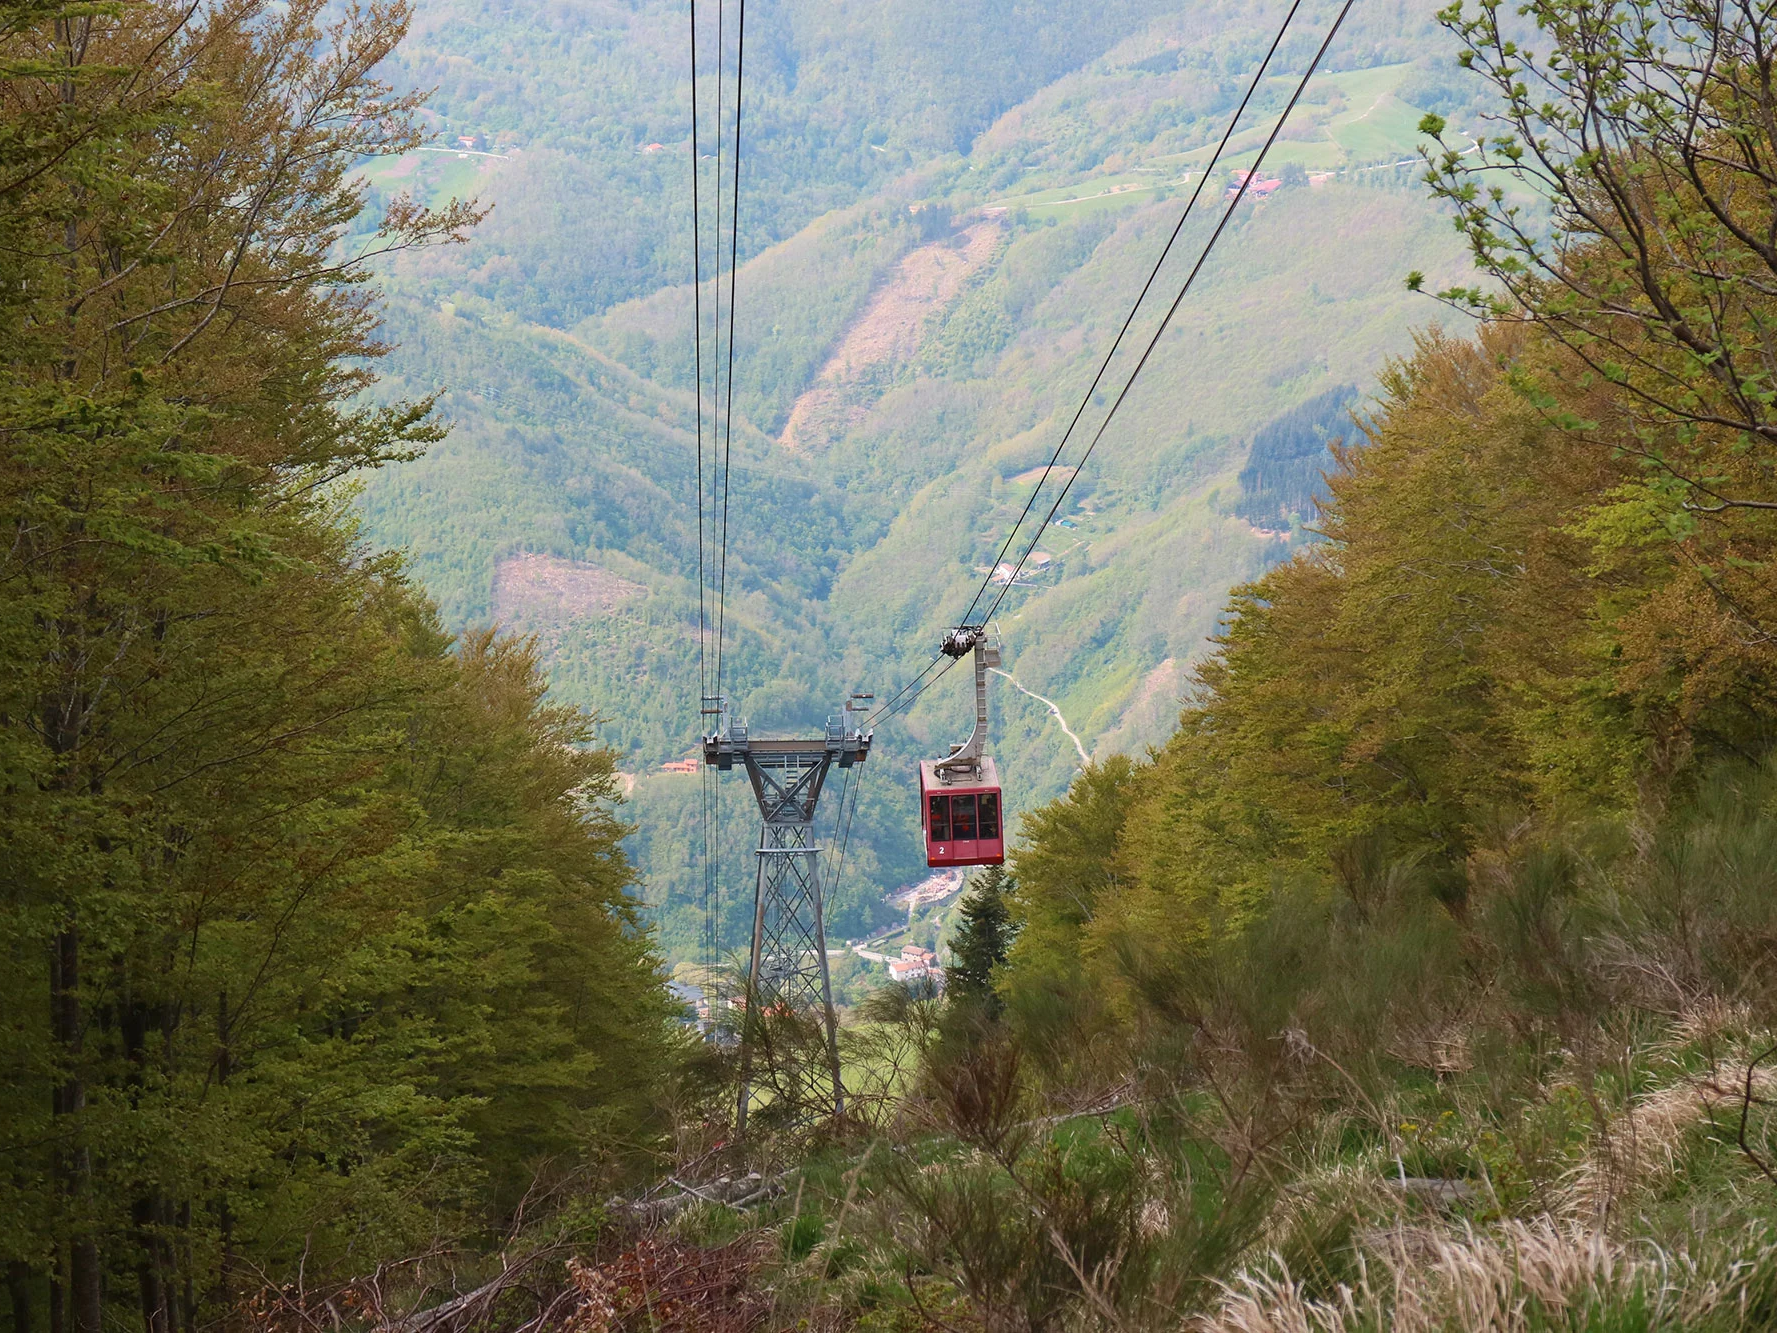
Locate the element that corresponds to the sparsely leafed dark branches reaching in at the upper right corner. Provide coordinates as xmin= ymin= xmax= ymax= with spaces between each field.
xmin=1409 ymin=0 xmax=1777 ymax=537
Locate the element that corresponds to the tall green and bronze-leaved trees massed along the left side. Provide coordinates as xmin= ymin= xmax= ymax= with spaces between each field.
xmin=0 ymin=4 xmax=675 ymax=1333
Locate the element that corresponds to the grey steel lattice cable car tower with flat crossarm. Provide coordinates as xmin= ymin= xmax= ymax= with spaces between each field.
xmin=704 ymin=695 xmax=873 ymax=1134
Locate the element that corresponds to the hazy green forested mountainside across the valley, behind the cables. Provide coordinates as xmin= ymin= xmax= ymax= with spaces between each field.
xmin=363 ymin=0 xmax=1470 ymax=949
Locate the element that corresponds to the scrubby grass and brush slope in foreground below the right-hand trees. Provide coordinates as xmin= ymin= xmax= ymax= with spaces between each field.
xmin=554 ymin=770 xmax=1777 ymax=1333
